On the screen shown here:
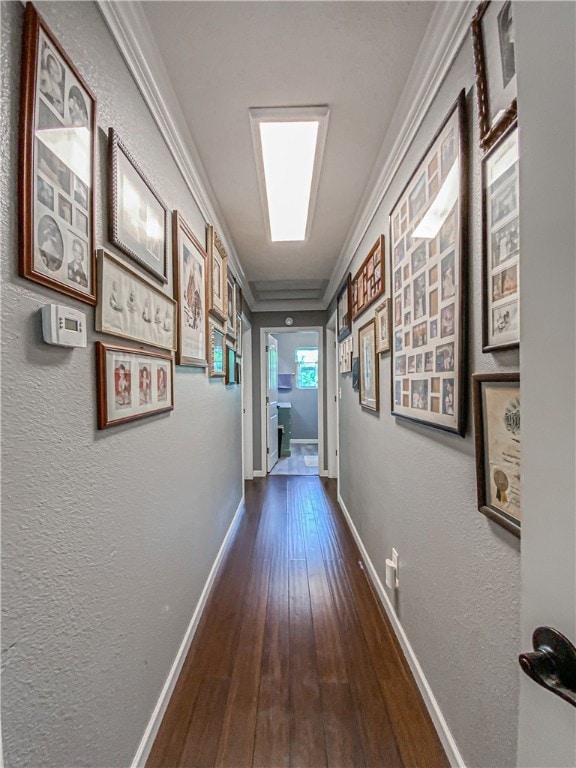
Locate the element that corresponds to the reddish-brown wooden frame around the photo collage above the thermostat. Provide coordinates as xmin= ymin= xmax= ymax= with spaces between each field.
xmin=18 ymin=2 xmax=96 ymax=305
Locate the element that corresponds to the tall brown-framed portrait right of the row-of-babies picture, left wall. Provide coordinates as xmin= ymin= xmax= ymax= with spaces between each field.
xmin=172 ymin=211 xmax=208 ymax=368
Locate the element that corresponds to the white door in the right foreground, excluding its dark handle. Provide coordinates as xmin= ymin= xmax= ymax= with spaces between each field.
xmin=516 ymin=2 xmax=576 ymax=768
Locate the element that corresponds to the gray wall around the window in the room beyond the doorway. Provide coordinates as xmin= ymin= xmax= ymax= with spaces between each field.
xmin=276 ymin=331 xmax=318 ymax=440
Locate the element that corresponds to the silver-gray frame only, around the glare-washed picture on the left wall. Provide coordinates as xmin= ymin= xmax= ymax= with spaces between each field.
xmin=108 ymin=128 xmax=169 ymax=283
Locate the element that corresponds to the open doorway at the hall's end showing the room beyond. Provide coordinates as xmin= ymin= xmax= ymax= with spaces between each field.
xmin=262 ymin=328 xmax=324 ymax=475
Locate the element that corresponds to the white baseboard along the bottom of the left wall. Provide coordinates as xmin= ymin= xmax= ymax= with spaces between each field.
xmin=130 ymin=496 xmax=244 ymax=768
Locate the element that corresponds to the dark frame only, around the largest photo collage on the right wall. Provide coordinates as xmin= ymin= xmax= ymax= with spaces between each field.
xmin=389 ymin=89 xmax=469 ymax=437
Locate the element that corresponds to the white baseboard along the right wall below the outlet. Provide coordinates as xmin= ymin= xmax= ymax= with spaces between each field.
xmin=338 ymin=491 xmax=466 ymax=768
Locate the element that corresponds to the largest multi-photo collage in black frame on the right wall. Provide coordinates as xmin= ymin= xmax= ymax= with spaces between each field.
xmin=390 ymin=90 xmax=469 ymax=436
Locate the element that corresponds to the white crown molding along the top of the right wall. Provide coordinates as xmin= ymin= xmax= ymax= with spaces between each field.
xmin=324 ymin=0 xmax=478 ymax=306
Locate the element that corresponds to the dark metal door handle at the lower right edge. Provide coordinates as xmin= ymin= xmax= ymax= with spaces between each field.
xmin=518 ymin=627 xmax=576 ymax=707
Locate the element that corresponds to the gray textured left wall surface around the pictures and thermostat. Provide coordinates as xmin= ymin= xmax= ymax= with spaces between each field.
xmin=0 ymin=2 xmax=241 ymax=768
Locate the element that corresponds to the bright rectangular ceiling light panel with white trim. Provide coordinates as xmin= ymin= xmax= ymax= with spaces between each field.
xmin=250 ymin=107 xmax=328 ymax=242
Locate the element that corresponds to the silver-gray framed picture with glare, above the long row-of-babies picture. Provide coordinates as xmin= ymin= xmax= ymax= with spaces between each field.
xmin=108 ymin=128 xmax=168 ymax=283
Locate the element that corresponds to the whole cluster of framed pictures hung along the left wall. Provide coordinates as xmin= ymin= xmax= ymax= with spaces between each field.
xmin=19 ymin=3 xmax=242 ymax=436
